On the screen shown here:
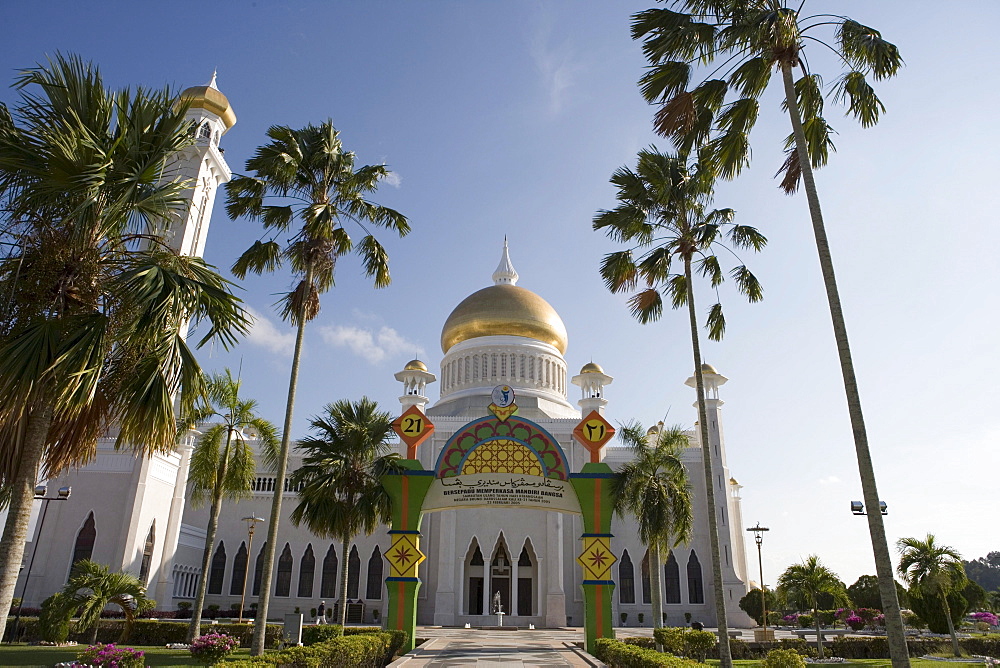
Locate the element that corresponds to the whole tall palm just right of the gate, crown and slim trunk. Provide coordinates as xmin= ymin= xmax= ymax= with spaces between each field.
xmin=594 ymin=147 xmax=767 ymax=668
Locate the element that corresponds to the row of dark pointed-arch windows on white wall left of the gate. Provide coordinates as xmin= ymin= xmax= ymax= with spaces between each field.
xmin=208 ymin=541 xmax=384 ymax=600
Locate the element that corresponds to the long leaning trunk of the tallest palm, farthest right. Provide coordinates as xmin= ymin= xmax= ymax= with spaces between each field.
xmin=781 ymin=62 xmax=910 ymax=668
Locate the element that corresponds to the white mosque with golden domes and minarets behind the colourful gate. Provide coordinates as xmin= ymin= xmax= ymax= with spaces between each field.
xmin=15 ymin=78 xmax=753 ymax=628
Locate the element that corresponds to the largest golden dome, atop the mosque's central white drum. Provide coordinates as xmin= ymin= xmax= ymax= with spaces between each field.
xmin=441 ymin=283 xmax=567 ymax=353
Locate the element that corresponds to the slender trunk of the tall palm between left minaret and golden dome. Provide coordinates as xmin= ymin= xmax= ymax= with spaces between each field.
xmin=248 ymin=266 xmax=313 ymax=656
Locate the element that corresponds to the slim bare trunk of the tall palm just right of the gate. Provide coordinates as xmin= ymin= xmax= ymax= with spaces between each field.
xmin=684 ymin=257 xmax=733 ymax=668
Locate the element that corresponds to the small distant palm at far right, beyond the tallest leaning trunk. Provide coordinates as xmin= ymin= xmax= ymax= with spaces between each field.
xmin=896 ymin=533 xmax=967 ymax=656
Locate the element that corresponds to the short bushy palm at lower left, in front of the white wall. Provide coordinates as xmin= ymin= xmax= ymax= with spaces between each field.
xmin=62 ymin=559 xmax=156 ymax=645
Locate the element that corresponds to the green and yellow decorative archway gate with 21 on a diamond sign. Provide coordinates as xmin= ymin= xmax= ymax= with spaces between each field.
xmin=382 ymin=386 xmax=616 ymax=651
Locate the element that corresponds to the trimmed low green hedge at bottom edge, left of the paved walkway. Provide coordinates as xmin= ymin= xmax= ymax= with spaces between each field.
xmin=220 ymin=631 xmax=405 ymax=668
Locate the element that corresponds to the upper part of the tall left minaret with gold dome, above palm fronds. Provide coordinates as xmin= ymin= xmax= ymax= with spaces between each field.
xmin=166 ymin=74 xmax=236 ymax=257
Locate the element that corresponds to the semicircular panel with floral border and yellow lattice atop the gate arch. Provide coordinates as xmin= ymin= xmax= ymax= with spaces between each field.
xmin=436 ymin=416 xmax=569 ymax=480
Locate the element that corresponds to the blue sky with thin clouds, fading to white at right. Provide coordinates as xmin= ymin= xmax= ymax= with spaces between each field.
xmin=0 ymin=0 xmax=1000 ymax=583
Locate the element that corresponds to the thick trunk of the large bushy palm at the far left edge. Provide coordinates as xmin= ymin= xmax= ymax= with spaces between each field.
xmin=0 ymin=404 xmax=54 ymax=630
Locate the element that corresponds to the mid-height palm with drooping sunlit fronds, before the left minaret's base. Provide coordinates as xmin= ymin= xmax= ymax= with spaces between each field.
xmin=187 ymin=369 xmax=278 ymax=641
